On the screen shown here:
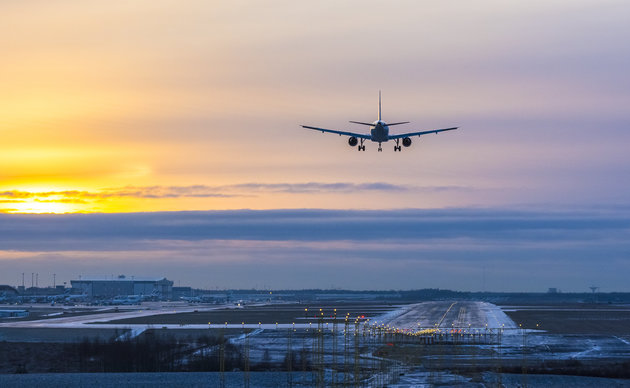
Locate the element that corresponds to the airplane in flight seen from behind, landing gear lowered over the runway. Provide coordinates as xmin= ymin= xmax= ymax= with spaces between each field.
xmin=302 ymin=90 xmax=459 ymax=152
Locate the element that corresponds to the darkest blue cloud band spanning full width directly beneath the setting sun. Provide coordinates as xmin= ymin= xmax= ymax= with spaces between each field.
xmin=0 ymin=208 xmax=630 ymax=250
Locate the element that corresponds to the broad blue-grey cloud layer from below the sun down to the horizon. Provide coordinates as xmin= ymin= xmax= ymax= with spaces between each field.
xmin=0 ymin=207 xmax=630 ymax=291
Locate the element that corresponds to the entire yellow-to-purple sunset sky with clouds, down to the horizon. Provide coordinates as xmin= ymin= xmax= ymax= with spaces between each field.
xmin=0 ymin=0 xmax=630 ymax=291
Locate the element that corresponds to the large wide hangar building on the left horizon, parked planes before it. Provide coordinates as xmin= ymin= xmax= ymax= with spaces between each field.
xmin=70 ymin=275 xmax=173 ymax=299
